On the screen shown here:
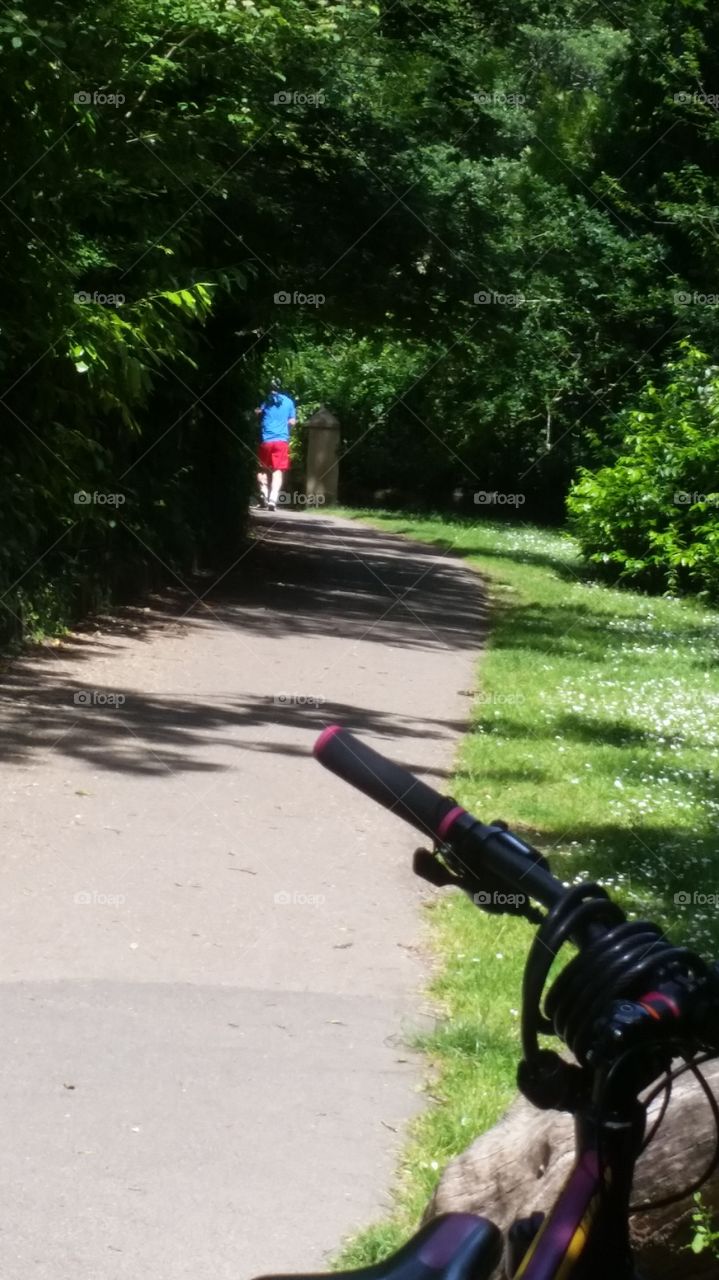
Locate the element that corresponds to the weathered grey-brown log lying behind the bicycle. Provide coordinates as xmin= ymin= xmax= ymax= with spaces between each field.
xmin=425 ymin=1062 xmax=719 ymax=1280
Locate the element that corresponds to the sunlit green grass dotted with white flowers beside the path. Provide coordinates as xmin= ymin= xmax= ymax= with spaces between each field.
xmin=327 ymin=511 xmax=719 ymax=1266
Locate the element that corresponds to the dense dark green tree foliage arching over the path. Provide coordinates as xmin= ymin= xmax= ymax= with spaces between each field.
xmin=0 ymin=0 xmax=719 ymax=632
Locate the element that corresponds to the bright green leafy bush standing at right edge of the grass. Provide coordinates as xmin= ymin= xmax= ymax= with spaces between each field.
xmin=568 ymin=342 xmax=719 ymax=599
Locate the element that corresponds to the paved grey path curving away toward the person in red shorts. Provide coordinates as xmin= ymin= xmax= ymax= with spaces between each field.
xmin=0 ymin=512 xmax=482 ymax=1280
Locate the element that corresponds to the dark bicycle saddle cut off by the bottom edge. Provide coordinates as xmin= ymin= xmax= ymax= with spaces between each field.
xmin=254 ymin=1213 xmax=502 ymax=1280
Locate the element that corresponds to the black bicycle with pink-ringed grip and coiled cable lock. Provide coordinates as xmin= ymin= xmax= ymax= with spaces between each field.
xmin=250 ymin=724 xmax=719 ymax=1280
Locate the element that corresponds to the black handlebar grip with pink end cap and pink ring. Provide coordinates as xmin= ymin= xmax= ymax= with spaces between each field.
xmin=315 ymin=724 xmax=462 ymax=840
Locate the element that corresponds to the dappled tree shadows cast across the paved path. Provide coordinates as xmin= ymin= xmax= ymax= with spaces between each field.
xmin=0 ymin=512 xmax=485 ymax=777
